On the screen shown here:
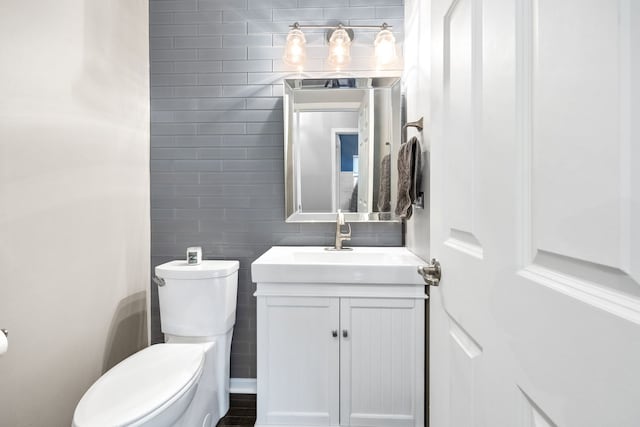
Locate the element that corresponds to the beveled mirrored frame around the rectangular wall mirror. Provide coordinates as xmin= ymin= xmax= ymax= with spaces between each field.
xmin=282 ymin=76 xmax=402 ymax=223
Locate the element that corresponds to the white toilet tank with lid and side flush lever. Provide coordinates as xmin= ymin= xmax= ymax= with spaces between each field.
xmin=155 ymin=260 xmax=240 ymax=337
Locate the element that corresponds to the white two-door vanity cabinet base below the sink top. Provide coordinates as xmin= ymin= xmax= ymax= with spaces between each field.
xmin=256 ymin=283 xmax=424 ymax=427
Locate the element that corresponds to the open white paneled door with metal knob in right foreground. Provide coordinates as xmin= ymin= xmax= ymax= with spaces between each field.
xmin=430 ymin=0 xmax=640 ymax=427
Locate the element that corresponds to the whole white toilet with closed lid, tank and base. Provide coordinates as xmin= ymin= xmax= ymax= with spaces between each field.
xmin=73 ymin=260 xmax=239 ymax=427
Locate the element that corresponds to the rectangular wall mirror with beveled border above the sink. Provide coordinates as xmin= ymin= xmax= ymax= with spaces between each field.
xmin=283 ymin=77 xmax=401 ymax=222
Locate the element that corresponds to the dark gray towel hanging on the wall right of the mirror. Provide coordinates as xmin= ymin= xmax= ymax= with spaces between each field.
xmin=396 ymin=136 xmax=422 ymax=218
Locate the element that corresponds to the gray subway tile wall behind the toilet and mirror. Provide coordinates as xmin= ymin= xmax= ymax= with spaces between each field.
xmin=150 ymin=0 xmax=404 ymax=378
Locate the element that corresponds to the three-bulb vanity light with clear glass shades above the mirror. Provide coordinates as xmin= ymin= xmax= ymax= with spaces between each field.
xmin=282 ymin=22 xmax=396 ymax=69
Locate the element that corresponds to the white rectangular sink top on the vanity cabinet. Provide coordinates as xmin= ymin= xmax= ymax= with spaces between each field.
xmin=251 ymin=246 xmax=424 ymax=285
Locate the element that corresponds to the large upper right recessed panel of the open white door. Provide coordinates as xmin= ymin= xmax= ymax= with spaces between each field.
xmin=518 ymin=1 xmax=640 ymax=305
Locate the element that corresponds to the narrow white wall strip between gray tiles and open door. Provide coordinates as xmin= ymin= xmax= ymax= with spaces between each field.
xmin=402 ymin=0 xmax=431 ymax=260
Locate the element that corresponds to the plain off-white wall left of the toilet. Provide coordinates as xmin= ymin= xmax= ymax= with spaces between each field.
xmin=0 ymin=0 xmax=149 ymax=427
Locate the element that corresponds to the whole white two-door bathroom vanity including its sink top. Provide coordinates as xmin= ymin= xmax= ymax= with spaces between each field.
xmin=251 ymin=246 xmax=426 ymax=427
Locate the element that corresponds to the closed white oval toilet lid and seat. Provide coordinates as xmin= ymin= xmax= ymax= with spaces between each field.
xmin=73 ymin=344 xmax=205 ymax=427
